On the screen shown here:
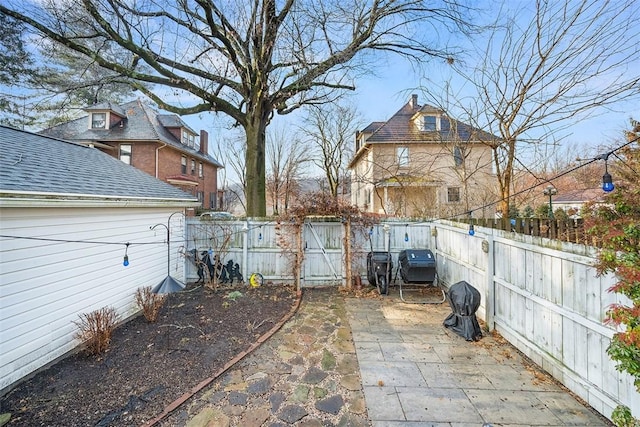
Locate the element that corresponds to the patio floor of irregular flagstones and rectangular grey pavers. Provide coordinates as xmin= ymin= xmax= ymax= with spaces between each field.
xmin=174 ymin=288 xmax=611 ymax=427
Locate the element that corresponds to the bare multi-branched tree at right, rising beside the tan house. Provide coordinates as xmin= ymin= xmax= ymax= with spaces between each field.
xmin=422 ymin=0 xmax=640 ymax=215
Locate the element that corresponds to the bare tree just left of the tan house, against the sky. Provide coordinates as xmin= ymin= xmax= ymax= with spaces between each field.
xmin=301 ymin=103 xmax=361 ymax=197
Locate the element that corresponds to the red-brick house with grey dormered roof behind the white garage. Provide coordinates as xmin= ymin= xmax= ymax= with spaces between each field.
xmin=40 ymin=100 xmax=223 ymax=210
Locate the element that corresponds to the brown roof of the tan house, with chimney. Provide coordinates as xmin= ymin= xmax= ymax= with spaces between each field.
xmin=363 ymin=95 xmax=497 ymax=143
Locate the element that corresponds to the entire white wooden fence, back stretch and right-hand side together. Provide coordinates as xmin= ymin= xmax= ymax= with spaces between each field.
xmin=184 ymin=219 xmax=640 ymax=417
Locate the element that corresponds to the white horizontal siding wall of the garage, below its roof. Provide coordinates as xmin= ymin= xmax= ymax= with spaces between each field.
xmin=0 ymin=208 xmax=184 ymax=390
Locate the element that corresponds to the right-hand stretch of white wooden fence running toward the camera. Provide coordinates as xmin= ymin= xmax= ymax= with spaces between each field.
xmin=434 ymin=221 xmax=640 ymax=418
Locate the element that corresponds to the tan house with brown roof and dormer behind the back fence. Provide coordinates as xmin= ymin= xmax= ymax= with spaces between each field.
xmin=349 ymin=95 xmax=496 ymax=218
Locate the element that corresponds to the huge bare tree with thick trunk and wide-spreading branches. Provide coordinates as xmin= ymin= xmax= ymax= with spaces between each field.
xmin=0 ymin=0 xmax=466 ymax=216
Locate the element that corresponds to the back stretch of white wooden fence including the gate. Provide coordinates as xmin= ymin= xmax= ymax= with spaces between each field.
xmin=183 ymin=218 xmax=431 ymax=287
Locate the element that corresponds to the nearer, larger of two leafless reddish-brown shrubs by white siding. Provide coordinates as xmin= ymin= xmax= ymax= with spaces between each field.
xmin=74 ymin=307 xmax=118 ymax=355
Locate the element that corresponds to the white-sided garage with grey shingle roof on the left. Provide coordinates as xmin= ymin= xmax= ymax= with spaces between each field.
xmin=0 ymin=126 xmax=200 ymax=394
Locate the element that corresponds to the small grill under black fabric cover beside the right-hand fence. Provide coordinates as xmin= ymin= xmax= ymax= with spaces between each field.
xmin=444 ymin=281 xmax=482 ymax=341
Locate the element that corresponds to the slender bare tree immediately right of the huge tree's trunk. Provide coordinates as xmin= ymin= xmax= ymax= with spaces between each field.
xmin=267 ymin=127 xmax=309 ymax=215
